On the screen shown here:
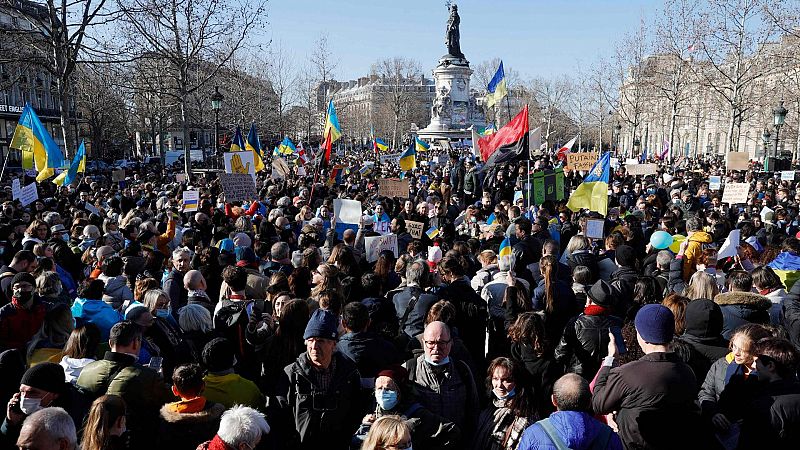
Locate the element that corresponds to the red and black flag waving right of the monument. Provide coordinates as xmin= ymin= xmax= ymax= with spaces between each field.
xmin=478 ymin=105 xmax=530 ymax=169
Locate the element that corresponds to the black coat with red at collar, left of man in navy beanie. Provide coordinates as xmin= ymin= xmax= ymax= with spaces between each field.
xmin=555 ymin=305 xmax=622 ymax=380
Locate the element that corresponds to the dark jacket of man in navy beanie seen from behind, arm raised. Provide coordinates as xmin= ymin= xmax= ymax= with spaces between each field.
xmin=592 ymin=352 xmax=701 ymax=449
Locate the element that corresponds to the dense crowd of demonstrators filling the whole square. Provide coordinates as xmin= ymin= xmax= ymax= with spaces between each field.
xmin=0 ymin=151 xmax=800 ymax=450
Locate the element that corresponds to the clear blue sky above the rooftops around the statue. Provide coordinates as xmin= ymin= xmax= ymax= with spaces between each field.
xmin=264 ymin=0 xmax=663 ymax=80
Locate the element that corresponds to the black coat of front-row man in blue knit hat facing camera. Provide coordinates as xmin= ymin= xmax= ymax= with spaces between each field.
xmin=276 ymin=352 xmax=364 ymax=450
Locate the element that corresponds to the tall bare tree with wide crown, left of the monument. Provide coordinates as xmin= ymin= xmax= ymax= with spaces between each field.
xmin=117 ymin=0 xmax=266 ymax=176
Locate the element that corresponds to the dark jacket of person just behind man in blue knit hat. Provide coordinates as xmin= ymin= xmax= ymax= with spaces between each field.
xmin=336 ymin=331 xmax=402 ymax=378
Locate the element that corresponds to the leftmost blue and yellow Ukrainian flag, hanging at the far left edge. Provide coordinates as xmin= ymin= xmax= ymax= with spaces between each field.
xmin=10 ymin=103 xmax=64 ymax=181
